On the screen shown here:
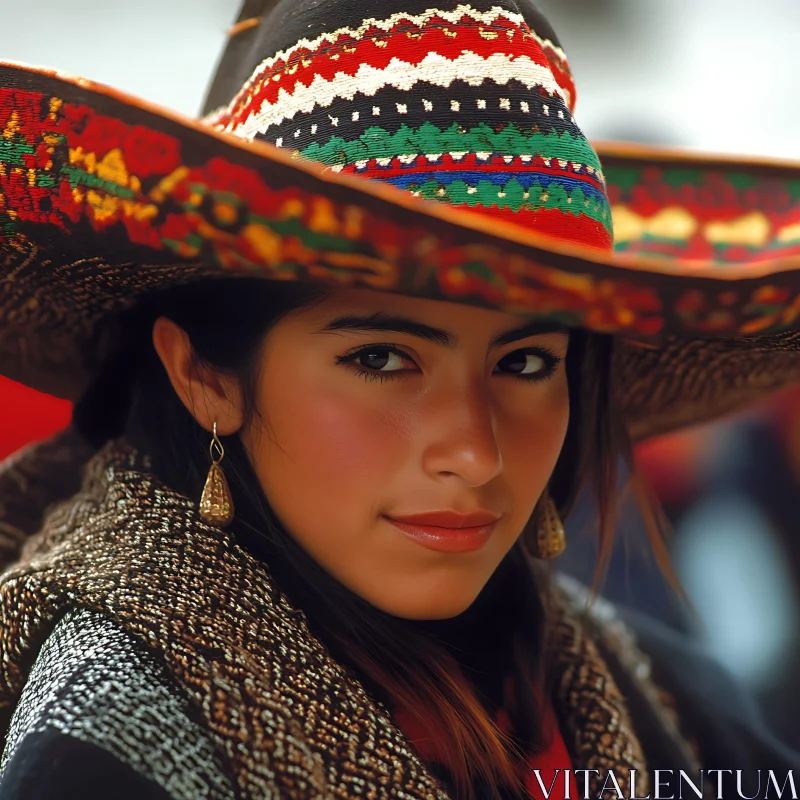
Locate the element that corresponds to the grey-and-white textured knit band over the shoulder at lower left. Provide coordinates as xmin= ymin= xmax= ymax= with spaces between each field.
xmin=0 ymin=608 xmax=234 ymax=800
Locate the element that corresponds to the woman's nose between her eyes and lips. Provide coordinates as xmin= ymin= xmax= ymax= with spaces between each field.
xmin=423 ymin=381 xmax=503 ymax=486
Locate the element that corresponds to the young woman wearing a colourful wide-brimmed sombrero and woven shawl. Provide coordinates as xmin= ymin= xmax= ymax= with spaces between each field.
xmin=0 ymin=0 xmax=800 ymax=799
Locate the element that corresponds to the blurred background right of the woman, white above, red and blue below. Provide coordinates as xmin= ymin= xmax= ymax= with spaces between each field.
xmin=535 ymin=0 xmax=800 ymax=749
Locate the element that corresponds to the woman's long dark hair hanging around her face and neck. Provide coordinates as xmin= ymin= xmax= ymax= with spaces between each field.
xmin=74 ymin=278 xmax=680 ymax=798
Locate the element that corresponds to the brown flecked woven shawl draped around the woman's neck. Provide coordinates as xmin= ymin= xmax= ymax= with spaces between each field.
xmin=0 ymin=437 xmax=688 ymax=800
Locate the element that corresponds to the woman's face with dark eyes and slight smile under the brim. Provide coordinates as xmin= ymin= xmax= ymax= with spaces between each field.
xmin=241 ymin=289 xmax=569 ymax=619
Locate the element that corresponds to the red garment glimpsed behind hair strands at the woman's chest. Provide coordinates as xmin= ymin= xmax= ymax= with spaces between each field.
xmin=393 ymin=678 xmax=579 ymax=800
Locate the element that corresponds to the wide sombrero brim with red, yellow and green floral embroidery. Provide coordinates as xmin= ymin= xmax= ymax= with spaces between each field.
xmin=0 ymin=62 xmax=800 ymax=438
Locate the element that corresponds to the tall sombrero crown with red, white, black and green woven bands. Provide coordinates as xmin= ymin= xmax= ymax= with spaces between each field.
xmin=207 ymin=0 xmax=613 ymax=249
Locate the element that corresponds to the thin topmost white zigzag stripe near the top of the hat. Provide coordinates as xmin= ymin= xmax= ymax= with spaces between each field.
xmin=204 ymin=4 xmax=567 ymax=128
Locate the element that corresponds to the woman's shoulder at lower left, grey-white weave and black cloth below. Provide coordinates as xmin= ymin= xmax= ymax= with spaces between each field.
xmin=0 ymin=608 xmax=234 ymax=800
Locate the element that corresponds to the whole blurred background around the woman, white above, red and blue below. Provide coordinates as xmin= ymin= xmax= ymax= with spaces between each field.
xmin=0 ymin=0 xmax=800 ymax=749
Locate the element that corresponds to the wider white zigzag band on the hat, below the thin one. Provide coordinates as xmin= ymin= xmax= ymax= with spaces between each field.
xmin=230 ymin=50 xmax=569 ymax=139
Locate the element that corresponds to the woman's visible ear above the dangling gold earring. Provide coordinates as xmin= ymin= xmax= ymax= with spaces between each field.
xmin=153 ymin=317 xmax=243 ymax=436
